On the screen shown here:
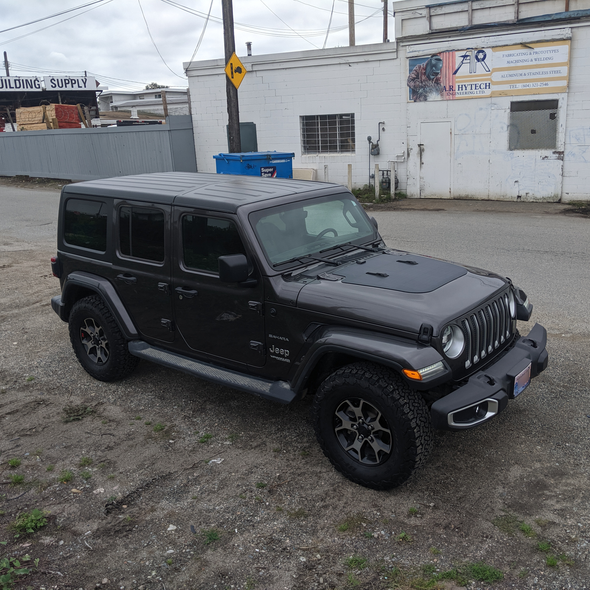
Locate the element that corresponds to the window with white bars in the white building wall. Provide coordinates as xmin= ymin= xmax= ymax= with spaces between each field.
xmin=301 ymin=113 xmax=354 ymax=154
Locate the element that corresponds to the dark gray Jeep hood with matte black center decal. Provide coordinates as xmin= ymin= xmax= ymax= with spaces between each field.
xmin=297 ymin=250 xmax=507 ymax=335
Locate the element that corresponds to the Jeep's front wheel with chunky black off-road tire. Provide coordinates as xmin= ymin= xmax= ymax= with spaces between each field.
xmin=313 ymin=362 xmax=433 ymax=490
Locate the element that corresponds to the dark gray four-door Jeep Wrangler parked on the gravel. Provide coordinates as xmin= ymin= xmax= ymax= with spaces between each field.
xmin=52 ymin=173 xmax=548 ymax=489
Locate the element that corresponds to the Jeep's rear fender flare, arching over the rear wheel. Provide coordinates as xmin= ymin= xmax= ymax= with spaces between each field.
xmin=52 ymin=271 xmax=139 ymax=340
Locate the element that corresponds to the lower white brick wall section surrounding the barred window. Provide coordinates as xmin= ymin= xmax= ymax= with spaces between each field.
xmin=188 ymin=44 xmax=406 ymax=186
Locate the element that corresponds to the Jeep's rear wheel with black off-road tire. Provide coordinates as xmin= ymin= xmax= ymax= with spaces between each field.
xmin=69 ymin=295 xmax=139 ymax=381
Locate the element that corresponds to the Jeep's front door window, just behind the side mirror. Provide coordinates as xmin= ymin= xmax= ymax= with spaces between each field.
xmin=182 ymin=215 xmax=246 ymax=273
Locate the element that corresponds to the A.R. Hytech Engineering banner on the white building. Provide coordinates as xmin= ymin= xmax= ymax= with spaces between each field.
xmin=407 ymin=40 xmax=570 ymax=102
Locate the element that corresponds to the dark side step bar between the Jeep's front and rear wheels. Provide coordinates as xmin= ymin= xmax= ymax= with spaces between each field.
xmin=129 ymin=340 xmax=296 ymax=404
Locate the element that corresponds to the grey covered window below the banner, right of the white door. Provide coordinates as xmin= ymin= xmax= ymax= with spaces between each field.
xmin=508 ymin=100 xmax=559 ymax=150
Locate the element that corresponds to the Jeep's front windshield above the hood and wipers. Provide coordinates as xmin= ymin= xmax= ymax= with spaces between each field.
xmin=250 ymin=194 xmax=376 ymax=266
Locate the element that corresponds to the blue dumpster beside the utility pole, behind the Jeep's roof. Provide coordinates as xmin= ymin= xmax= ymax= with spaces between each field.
xmin=213 ymin=152 xmax=295 ymax=178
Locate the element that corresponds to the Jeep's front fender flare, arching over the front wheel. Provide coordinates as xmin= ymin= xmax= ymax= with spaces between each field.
xmin=291 ymin=326 xmax=451 ymax=392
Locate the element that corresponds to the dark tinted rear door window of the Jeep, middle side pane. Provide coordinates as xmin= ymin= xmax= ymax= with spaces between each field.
xmin=119 ymin=207 xmax=164 ymax=262
